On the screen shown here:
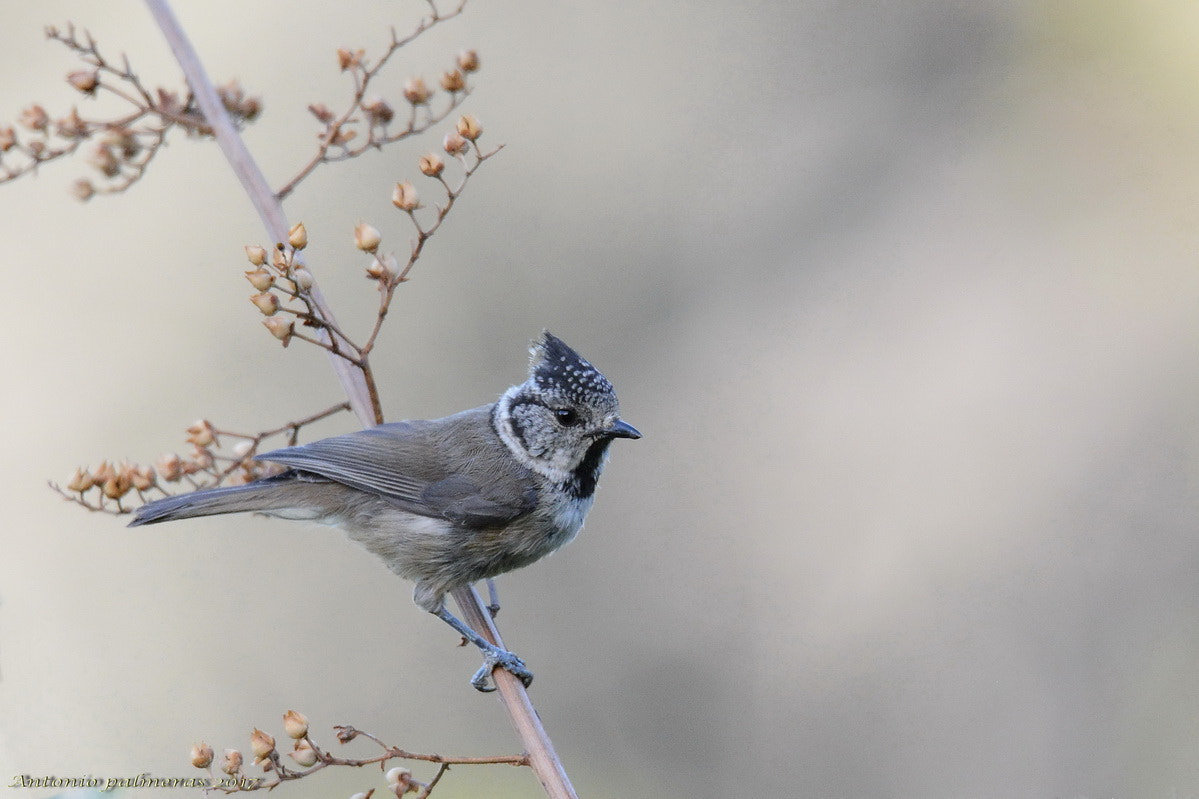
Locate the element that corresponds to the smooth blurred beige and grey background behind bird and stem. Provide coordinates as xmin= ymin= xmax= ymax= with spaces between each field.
xmin=0 ymin=0 xmax=1199 ymax=799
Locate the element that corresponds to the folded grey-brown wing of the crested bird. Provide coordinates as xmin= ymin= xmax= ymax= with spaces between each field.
xmin=255 ymin=408 xmax=537 ymax=528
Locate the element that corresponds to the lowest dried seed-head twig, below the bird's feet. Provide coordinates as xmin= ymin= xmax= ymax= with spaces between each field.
xmin=192 ymin=710 xmax=529 ymax=799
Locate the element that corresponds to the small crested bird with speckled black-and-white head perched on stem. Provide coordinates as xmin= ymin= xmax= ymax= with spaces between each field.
xmin=129 ymin=330 xmax=641 ymax=691
